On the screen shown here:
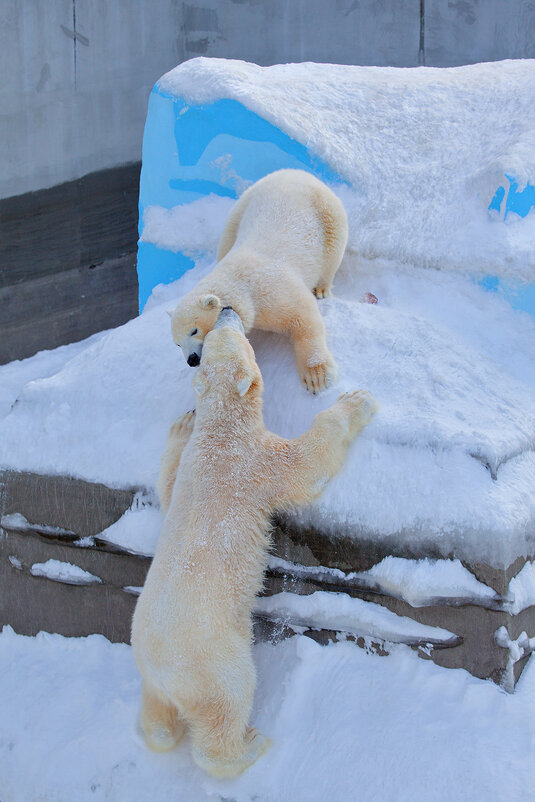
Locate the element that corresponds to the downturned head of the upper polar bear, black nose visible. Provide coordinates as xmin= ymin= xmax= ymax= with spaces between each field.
xmin=168 ymin=293 xmax=221 ymax=368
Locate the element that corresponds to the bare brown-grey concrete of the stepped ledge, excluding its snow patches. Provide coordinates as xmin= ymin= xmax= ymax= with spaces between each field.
xmin=0 ymin=472 xmax=535 ymax=689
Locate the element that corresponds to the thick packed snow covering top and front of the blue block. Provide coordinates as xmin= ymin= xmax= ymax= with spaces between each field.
xmin=158 ymin=58 xmax=535 ymax=281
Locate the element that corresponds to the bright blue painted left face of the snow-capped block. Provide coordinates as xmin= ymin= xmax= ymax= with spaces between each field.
xmin=137 ymin=85 xmax=346 ymax=311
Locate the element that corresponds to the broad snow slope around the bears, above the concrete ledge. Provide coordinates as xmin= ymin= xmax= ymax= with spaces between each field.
xmin=0 ymin=253 xmax=535 ymax=567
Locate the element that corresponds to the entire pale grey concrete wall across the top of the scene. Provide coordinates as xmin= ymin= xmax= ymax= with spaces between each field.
xmin=0 ymin=0 xmax=535 ymax=197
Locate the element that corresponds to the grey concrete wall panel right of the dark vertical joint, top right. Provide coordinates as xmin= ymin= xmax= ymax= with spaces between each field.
xmin=424 ymin=0 xmax=535 ymax=67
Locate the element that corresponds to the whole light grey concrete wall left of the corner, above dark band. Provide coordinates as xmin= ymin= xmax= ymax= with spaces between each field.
xmin=0 ymin=0 xmax=183 ymax=197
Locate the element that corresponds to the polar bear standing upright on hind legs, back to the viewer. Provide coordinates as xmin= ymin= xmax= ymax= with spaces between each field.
xmin=132 ymin=310 xmax=375 ymax=777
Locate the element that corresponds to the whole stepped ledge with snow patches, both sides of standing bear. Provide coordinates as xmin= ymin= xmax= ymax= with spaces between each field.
xmin=0 ymin=474 xmax=535 ymax=688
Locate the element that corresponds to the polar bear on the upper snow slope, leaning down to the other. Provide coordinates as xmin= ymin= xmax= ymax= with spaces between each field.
xmin=169 ymin=170 xmax=347 ymax=393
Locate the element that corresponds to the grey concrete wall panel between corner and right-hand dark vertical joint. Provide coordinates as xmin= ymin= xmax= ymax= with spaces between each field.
xmin=183 ymin=0 xmax=420 ymax=67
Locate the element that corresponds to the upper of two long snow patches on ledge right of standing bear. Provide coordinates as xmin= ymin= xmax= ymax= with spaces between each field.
xmin=269 ymin=556 xmax=500 ymax=607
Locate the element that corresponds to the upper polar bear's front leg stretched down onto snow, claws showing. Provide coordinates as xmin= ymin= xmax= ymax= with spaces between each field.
xmin=289 ymin=293 xmax=337 ymax=394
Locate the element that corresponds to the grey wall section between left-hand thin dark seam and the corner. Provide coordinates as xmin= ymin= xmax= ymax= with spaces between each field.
xmin=61 ymin=0 xmax=182 ymax=190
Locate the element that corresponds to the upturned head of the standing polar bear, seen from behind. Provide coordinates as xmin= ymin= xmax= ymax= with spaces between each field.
xmin=193 ymin=307 xmax=263 ymax=404
